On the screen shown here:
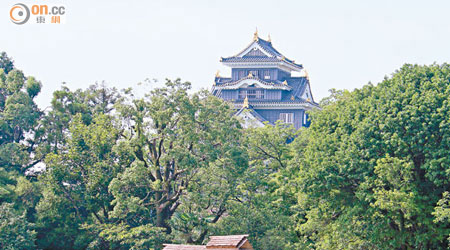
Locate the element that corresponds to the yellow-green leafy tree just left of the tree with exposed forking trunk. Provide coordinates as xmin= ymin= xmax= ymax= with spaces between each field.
xmin=37 ymin=114 xmax=127 ymax=249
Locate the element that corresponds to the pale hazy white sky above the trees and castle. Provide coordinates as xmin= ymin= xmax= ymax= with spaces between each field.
xmin=0 ymin=0 xmax=450 ymax=107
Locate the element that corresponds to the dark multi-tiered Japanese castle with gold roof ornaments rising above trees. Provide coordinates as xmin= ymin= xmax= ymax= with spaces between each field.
xmin=212 ymin=31 xmax=319 ymax=129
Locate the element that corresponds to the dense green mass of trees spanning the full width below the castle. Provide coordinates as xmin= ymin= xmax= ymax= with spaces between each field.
xmin=0 ymin=53 xmax=450 ymax=250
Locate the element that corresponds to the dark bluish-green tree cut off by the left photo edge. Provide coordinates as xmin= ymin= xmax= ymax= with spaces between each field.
xmin=0 ymin=52 xmax=42 ymax=249
